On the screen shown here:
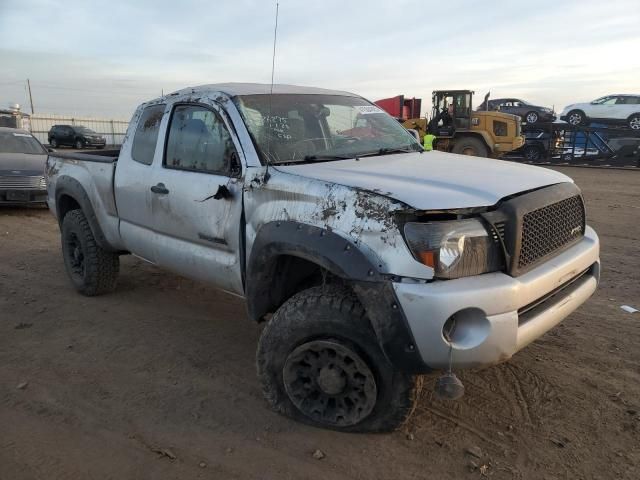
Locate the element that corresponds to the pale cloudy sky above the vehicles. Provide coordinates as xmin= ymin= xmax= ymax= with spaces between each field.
xmin=0 ymin=0 xmax=640 ymax=119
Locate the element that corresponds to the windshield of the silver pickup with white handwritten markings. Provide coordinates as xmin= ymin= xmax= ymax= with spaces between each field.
xmin=234 ymin=94 xmax=422 ymax=164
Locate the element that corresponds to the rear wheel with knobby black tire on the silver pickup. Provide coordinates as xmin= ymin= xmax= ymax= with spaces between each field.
xmin=62 ymin=210 xmax=120 ymax=297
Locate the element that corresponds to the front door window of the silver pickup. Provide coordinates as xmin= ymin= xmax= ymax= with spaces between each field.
xmin=164 ymin=105 xmax=237 ymax=175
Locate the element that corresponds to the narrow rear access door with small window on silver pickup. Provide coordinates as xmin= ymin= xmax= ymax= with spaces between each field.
xmin=114 ymin=104 xmax=166 ymax=263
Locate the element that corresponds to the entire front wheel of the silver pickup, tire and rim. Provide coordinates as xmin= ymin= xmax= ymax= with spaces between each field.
xmin=256 ymin=286 xmax=422 ymax=432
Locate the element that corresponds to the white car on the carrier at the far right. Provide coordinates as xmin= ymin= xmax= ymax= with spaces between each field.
xmin=560 ymin=94 xmax=640 ymax=130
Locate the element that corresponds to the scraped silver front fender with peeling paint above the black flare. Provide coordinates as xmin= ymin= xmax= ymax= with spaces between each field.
xmin=244 ymin=166 xmax=433 ymax=281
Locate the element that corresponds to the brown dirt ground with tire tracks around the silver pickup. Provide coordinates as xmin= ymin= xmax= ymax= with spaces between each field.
xmin=0 ymin=168 xmax=640 ymax=480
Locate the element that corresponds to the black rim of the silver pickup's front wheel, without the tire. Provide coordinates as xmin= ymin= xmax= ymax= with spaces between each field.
xmin=283 ymin=340 xmax=378 ymax=427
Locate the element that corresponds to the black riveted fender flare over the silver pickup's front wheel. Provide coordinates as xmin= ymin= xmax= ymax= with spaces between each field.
xmin=245 ymin=221 xmax=429 ymax=373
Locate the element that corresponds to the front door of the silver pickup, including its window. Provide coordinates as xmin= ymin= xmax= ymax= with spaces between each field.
xmin=151 ymin=103 xmax=243 ymax=294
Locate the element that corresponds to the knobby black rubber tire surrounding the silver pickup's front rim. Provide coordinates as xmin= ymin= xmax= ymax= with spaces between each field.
xmin=256 ymin=285 xmax=422 ymax=432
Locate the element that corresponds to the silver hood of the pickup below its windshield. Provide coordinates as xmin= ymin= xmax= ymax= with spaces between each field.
xmin=275 ymin=151 xmax=572 ymax=210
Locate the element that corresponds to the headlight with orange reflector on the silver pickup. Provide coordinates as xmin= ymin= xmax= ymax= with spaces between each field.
xmin=404 ymin=219 xmax=504 ymax=279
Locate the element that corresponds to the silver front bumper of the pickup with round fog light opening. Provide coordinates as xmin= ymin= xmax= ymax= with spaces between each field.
xmin=393 ymin=227 xmax=600 ymax=368
